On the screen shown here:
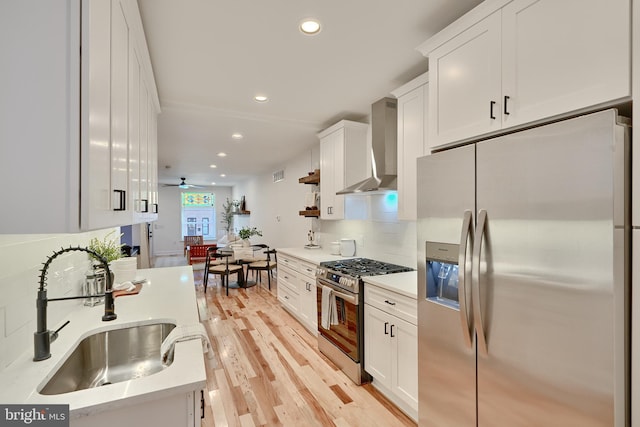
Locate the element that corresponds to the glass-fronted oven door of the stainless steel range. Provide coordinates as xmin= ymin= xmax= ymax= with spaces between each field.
xmin=316 ymin=277 xmax=361 ymax=362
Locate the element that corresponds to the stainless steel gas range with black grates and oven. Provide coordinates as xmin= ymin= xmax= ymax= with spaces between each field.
xmin=316 ymin=258 xmax=413 ymax=384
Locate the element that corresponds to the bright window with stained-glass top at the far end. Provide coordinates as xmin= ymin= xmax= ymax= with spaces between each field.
xmin=181 ymin=192 xmax=216 ymax=240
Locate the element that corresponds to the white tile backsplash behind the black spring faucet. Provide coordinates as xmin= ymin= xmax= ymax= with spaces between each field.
xmin=0 ymin=228 xmax=119 ymax=370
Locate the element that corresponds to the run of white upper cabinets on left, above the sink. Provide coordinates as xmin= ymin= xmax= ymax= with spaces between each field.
xmin=0 ymin=0 xmax=159 ymax=233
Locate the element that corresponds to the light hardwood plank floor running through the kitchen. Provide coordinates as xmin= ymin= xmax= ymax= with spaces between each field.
xmin=154 ymin=257 xmax=416 ymax=427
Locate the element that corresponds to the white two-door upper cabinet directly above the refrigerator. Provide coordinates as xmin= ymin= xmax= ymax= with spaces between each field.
xmin=419 ymin=0 xmax=631 ymax=146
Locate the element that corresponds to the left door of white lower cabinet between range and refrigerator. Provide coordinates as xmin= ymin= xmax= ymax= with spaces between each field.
xmin=364 ymin=304 xmax=392 ymax=388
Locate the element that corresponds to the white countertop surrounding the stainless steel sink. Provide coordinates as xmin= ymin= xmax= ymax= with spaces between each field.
xmin=0 ymin=266 xmax=206 ymax=418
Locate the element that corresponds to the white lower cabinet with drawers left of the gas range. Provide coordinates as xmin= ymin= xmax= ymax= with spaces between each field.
xmin=278 ymin=253 xmax=318 ymax=335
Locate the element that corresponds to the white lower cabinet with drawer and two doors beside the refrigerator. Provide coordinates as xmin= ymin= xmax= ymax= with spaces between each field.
xmin=364 ymin=283 xmax=418 ymax=420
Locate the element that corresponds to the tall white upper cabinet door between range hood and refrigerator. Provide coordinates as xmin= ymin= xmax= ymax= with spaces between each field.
xmin=398 ymin=84 xmax=429 ymax=220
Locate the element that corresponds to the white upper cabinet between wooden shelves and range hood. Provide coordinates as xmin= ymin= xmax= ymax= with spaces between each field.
xmin=318 ymin=120 xmax=369 ymax=219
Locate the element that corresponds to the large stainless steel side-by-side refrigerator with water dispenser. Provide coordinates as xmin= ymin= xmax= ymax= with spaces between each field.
xmin=417 ymin=110 xmax=630 ymax=427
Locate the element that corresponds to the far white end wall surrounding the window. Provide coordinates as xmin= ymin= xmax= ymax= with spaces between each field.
xmin=151 ymin=186 xmax=231 ymax=256
